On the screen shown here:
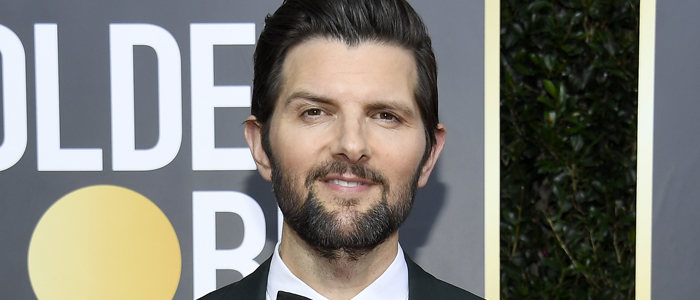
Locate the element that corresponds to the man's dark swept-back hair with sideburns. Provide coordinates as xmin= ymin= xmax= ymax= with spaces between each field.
xmin=251 ymin=0 xmax=439 ymax=160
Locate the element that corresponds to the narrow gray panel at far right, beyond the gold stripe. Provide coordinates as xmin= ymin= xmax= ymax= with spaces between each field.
xmin=651 ymin=0 xmax=700 ymax=299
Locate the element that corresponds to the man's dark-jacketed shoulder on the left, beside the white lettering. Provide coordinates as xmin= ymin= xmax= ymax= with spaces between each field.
xmin=199 ymin=259 xmax=270 ymax=300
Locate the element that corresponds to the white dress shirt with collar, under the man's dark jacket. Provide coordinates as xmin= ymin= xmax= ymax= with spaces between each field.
xmin=265 ymin=242 xmax=408 ymax=300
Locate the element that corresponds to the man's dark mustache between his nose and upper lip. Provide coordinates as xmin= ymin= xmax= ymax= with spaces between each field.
xmin=304 ymin=160 xmax=389 ymax=187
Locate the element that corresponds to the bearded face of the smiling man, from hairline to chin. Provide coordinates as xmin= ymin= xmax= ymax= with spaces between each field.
xmin=246 ymin=38 xmax=444 ymax=256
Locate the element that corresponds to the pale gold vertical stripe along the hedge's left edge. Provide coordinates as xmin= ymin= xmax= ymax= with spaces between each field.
xmin=484 ymin=0 xmax=501 ymax=300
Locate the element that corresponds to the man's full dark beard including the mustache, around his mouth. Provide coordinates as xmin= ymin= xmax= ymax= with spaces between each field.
xmin=271 ymin=159 xmax=420 ymax=260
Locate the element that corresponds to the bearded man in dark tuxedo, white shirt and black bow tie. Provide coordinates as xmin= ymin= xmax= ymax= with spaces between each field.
xmin=197 ymin=0 xmax=480 ymax=300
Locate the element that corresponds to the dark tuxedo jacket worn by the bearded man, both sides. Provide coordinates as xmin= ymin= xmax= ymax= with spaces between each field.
xmin=199 ymin=255 xmax=482 ymax=300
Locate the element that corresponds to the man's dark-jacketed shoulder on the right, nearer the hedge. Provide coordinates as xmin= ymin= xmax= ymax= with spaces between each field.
xmin=406 ymin=256 xmax=483 ymax=300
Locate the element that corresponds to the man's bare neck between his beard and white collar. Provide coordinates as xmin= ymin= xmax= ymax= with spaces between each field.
xmin=280 ymin=223 xmax=399 ymax=300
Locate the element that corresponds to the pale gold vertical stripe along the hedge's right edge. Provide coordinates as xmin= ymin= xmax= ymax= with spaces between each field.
xmin=635 ymin=0 xmax=656 ymax=300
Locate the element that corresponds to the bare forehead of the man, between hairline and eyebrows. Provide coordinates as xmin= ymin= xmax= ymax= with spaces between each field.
xmin=277 ymin=38 xmax=417 ymax=107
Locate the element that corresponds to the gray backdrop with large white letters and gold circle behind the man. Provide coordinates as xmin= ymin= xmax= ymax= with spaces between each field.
xmin=0 ymin=0 xmax=490 ymax=299
